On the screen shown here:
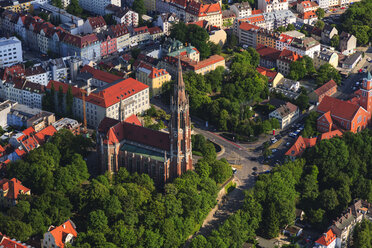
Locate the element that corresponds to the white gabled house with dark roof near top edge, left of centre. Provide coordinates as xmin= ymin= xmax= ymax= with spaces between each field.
xmin=105 ymin=4 xmax=139 ymax=27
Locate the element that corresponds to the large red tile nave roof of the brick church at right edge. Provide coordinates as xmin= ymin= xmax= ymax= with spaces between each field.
xmin=318 ymin=96 xmax=360 ymax=121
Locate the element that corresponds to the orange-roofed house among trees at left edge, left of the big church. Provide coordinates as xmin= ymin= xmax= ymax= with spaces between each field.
xmin=0 ymin=178 xmax=31 ymax=208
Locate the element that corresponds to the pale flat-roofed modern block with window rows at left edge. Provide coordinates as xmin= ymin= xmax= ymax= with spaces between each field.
xmin=0 ymin=36 xmax=23 ymax=68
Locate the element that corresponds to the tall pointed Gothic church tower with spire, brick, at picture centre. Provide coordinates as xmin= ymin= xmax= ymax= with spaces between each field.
xmin=169 ymin=58 xmax=192 ymax=179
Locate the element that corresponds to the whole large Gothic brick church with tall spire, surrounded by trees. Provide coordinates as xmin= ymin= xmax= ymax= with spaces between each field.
xmin=97 ymin=60 xmax=192 ymax=186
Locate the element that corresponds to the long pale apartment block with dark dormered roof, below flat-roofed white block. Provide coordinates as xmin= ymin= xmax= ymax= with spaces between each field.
xmin=4 ymin=78 xmax=44 ymax=109
